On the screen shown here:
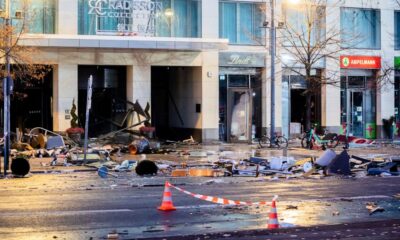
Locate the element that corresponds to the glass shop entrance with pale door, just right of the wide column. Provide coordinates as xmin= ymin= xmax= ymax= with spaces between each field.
xmin=219 ymin=68 xmax=262 ymax=143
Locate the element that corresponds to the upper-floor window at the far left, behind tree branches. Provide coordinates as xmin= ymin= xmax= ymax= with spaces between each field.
xmin=0 ymin=0 xmax=55 ymax=34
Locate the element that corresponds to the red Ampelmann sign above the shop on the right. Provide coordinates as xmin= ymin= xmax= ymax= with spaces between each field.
xmin=340 ymin=56 xmax=381 ymax=69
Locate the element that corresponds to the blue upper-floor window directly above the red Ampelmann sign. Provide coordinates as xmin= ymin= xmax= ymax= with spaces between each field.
xmin=340 ymin=8 xmax=381 ymax=49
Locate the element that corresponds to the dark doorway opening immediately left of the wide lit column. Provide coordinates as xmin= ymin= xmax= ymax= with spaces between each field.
xmin=151 ymin=67 xmax=198 ymax=141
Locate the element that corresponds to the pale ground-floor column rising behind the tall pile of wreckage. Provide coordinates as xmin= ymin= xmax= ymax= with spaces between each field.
xmin=126 ymin=65 xmax=151 ymax=128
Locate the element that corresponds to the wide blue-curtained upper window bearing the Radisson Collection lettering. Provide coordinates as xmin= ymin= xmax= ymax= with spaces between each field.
xmin=78 ymin=0 xmax=201 ymax=38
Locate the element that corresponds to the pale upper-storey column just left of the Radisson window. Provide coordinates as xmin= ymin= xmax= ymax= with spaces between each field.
xmin=56 ymin=0 xmax=78 ymax=35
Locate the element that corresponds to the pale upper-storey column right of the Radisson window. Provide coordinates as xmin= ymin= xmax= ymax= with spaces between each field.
xmin=201 ymin=1 xmax=219 ymax=38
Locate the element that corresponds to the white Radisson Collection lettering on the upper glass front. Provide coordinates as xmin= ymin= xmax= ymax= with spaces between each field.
xmin=88 ymin=0 xmax=164 ymax=36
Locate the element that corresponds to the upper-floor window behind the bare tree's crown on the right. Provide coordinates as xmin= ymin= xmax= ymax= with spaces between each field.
xmin=281 ymin=5 xmax=326 ymax=46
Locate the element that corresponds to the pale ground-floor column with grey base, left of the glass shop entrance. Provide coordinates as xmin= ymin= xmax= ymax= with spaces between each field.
xmin=201 ymin=50 xmax=219 ymax=142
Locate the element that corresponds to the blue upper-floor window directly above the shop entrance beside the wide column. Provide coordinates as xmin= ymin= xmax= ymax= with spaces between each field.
xmin=219 ymin=1 xmax=265 ymax=45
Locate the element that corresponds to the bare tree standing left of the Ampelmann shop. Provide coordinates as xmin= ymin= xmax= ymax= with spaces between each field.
xmin=280 ymin=0 xmax=345 ymax=129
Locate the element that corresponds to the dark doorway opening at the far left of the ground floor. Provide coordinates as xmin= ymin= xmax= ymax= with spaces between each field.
xmin=9 ymin=66 xmax=53 ymax=132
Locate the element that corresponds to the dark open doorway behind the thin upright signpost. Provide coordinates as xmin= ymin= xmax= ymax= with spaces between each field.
xmin=78 ymin=66 xmax=127 ymax=137
